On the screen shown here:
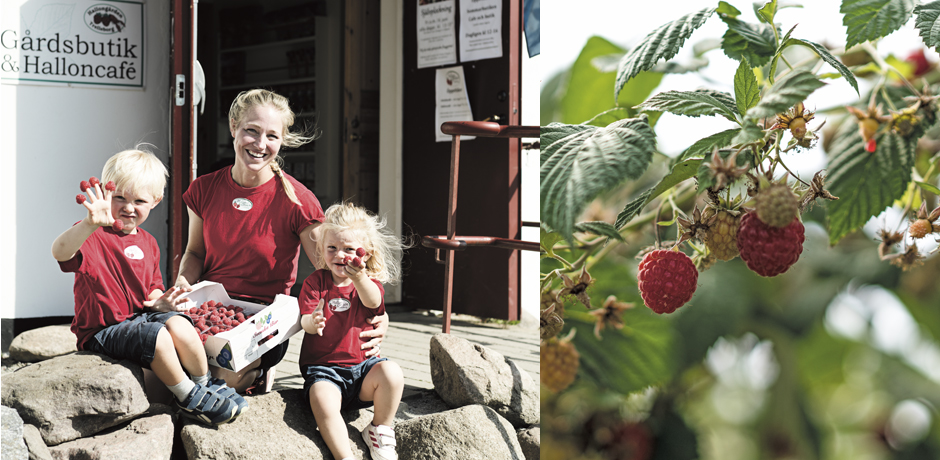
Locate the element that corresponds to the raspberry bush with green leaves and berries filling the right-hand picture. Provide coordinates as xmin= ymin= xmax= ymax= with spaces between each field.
xmin=540 ymin=0 xmax=940 ymax=459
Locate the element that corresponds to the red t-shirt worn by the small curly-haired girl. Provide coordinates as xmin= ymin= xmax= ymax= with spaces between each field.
xmin=300 ymin=269 xmax=385 ymax=367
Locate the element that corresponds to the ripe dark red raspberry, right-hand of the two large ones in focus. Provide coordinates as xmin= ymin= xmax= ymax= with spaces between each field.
xmin=738 ymin=212 xmax=804 ymax=276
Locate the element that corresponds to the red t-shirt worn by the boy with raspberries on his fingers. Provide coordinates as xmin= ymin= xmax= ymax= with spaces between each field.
xmin=59 ymin=227 xmax=163 ymax=350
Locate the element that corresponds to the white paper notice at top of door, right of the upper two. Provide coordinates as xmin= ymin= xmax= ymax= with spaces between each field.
xmin=460 ymin=0 xmax=503 ymax=62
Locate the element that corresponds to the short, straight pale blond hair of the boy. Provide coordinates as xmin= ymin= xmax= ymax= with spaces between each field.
xmin=101 ymin=145 xmax=169 ymax=200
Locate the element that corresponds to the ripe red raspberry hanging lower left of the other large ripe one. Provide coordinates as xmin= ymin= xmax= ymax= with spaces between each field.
xmin=637 ymin=249 xmax=698 ymax=314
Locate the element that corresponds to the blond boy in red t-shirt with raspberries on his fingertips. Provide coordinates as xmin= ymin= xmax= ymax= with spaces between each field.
xmin=52 ymin=150 xmax=245 ymax=425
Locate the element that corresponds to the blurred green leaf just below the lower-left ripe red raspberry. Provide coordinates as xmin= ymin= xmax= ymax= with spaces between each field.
xmin=565 ymin=304 xmax=676 ymax=394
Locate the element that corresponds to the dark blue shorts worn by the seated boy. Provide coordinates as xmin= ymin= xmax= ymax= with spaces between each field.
xmin=85 ymin=311 xmax=193 ymax=369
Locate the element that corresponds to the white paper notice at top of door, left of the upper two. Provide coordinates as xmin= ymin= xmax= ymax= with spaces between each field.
xmin=417 ymin=0 xmax=457 ymax=69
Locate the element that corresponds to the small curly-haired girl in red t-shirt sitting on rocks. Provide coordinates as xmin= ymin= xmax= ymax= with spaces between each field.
xmin=300 ymin=203 xmax=405 ymax=460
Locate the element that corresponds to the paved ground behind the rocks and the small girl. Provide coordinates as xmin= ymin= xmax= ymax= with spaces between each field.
xmin=274 ymin=306 xmax=539 ymax=397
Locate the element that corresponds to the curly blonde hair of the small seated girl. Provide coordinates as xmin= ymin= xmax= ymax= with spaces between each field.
xmin=317 ymin=202 xmax=410 ymax=284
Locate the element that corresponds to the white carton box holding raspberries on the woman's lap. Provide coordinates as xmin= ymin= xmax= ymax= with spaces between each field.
xmin=179 ymin=281 xmax=301 ymax=372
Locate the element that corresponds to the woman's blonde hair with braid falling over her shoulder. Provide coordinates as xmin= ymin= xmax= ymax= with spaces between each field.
xmin=228 ymin=89 xmax=320 ymax=206
